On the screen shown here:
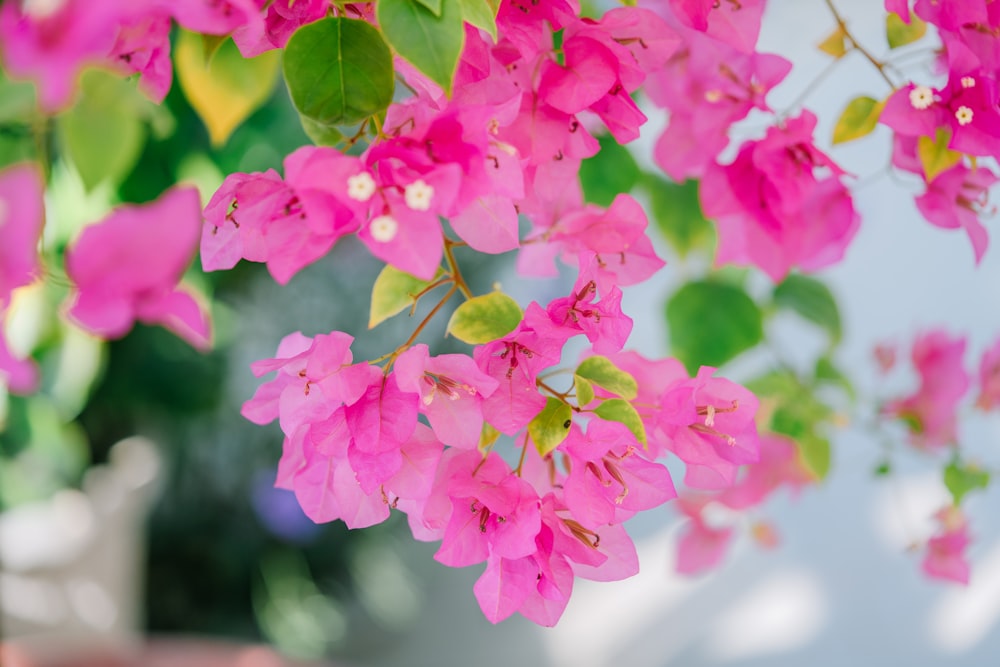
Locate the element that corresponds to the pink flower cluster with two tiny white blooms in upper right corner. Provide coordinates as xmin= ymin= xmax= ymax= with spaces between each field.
xmin=880 ymin=0 xmax=1000 ymax=262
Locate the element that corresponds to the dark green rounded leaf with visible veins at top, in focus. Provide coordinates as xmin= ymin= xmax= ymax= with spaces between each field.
xmin=284 ymin=16 xmax=394 ymax=126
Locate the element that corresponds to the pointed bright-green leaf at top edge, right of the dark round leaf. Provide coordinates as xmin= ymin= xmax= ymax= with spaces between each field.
xmin=375 ymin=0 xmax=465 ymax=95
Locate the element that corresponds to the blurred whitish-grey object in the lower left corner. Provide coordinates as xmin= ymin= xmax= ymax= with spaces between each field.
xmin=0 ymin=437 xmax=161 ymax=646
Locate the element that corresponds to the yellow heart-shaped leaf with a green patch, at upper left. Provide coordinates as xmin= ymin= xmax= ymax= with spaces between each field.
xmin=174 ymin=30 xmax=281 ymax=146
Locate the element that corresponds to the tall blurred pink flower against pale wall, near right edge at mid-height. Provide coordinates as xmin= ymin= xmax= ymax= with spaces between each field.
xmin=884 ymin=331 xmax=971 ymax=449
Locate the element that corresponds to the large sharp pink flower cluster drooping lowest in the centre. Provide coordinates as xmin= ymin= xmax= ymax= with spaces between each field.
xmin=243 ymin=320 xmax=770 ymax=625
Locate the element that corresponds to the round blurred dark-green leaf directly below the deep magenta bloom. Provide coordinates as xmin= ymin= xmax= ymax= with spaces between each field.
xmin=667 ymin=281 xmax=764 ymax=374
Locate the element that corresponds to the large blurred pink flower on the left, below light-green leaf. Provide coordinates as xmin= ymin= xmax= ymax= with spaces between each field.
xmin=66 ymin=187 xmax=209 ymax=349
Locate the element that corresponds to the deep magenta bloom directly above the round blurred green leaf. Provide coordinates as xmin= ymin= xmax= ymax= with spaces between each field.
xmin=700 ymin=111 xmax=860 ymax=281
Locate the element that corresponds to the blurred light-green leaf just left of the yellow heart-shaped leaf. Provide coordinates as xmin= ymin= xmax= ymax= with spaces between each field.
xmin=56 ymin=70 xmax=146 ymax=191
